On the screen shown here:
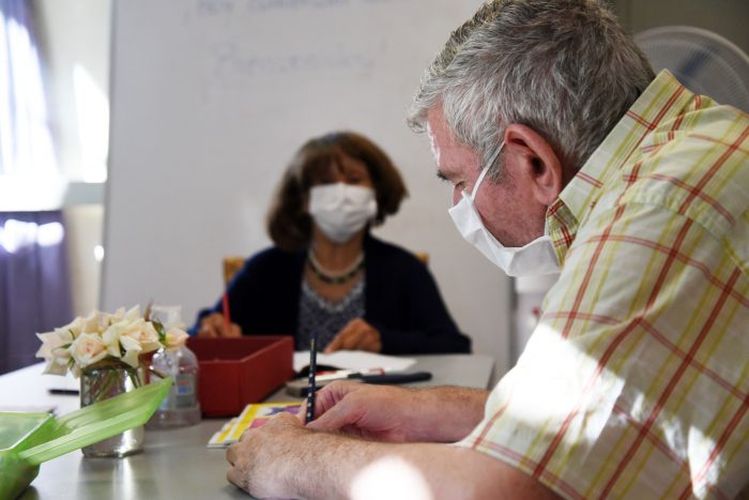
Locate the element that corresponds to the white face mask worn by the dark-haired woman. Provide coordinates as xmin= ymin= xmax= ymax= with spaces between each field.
xmin=309 ymin=182 xmax=377 ymax=243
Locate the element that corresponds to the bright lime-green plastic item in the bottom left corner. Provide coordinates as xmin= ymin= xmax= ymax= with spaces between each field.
xmin=0 ymin=378 xmax=172 ymax=499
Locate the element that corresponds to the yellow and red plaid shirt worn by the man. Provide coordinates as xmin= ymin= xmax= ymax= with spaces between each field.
xmin=458 ymin=71 xmax=749 ymax=498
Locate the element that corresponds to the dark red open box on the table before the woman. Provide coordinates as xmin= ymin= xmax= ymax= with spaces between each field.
xmin=187 ymin=335 xmax=294 ymax=417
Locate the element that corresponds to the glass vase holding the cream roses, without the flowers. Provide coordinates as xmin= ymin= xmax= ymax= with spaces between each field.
xmin=81 ymin=361 xmax=145 ymax=457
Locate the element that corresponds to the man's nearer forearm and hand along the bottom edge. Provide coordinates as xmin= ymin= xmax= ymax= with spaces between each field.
xmin=284 ymin=432 xmax=554 ymax=500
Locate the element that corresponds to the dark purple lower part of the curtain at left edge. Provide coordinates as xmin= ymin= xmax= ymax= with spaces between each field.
xmin=0 ymin=210 xmax=72 ymax=373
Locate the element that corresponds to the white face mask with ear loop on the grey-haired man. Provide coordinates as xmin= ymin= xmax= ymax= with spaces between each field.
xmin=448 ymin=142 xmax=559 ymax=277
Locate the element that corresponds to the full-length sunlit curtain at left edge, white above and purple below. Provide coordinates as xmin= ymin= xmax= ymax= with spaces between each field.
xmin=0 ymin=0 xmax=72 ymax=373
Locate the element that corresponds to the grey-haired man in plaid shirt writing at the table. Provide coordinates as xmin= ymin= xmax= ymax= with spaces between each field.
xmin=227 ymin=0 xmax=749 ymax=498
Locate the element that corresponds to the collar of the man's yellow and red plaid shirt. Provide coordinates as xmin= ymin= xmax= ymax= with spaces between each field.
xmin=546 ymin=70 xmax=693 ymax=263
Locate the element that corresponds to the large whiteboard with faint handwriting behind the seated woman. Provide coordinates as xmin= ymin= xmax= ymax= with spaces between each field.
xmin=101 ymin=0 xmax=510 ymax=376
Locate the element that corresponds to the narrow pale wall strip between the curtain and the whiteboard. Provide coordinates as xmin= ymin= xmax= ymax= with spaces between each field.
xmin=31 ymin=0 xmax=112 ymax=315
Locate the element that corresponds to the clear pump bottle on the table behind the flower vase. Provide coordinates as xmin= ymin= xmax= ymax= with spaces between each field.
xmin=146 ymin=306 xmax=200 ymax=429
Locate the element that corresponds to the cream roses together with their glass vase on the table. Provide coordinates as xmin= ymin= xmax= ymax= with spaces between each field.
xmin=36 ymin=306 xmax=188 ymax=456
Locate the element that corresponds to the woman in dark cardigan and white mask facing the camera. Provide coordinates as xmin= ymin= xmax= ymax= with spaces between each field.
xmin=194 ymin=132 xmax=471 ymax=354
